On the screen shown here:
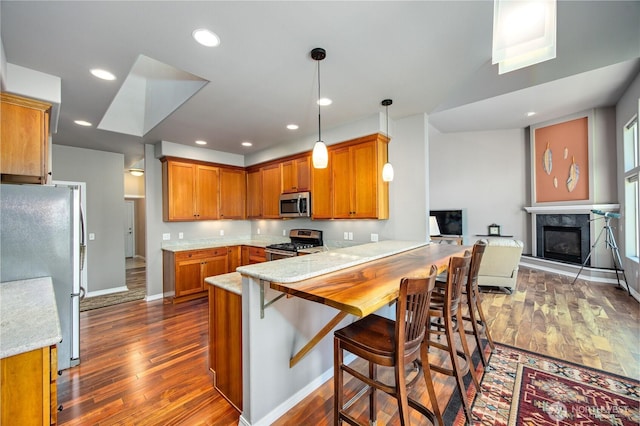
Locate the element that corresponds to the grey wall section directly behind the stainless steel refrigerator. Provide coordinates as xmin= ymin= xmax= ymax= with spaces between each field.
xmin=51 ymin=145 xmax=126 ymax=294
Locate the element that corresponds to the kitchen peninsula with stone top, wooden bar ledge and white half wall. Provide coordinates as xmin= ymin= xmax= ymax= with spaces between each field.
xmin=221 ymin=241 xmax=468 ymax=425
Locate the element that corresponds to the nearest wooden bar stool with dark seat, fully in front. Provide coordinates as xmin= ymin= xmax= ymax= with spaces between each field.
xmin=334 ymin=265 xmax=438 ymax=425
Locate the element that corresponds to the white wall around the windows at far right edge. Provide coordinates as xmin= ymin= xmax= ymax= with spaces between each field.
xmin=616 ymin=74 xmax=640 ymax=292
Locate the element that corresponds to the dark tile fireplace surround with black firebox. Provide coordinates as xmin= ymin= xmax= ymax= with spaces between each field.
xmin=536 ymin=214 xmax=591 ymax=266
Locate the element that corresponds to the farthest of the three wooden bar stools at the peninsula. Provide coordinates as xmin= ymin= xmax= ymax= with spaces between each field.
xmin=463 ymin=241 xmax=495 ymax=367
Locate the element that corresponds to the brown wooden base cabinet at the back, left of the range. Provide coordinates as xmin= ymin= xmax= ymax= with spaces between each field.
xmin=163 ymin=247 xmax=229 ymax=303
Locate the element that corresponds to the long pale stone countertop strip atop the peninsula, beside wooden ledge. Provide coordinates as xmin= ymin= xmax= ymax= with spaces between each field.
xmin=236 ymin=240 xmax=428 ymax=283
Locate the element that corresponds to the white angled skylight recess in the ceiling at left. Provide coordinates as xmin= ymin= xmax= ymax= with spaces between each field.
xmin=98 ymin=55 xmax=209 ymax=137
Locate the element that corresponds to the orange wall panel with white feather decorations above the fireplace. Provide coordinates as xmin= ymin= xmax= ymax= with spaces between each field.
xmin=533 ymin=117 xmax=589 ymax=203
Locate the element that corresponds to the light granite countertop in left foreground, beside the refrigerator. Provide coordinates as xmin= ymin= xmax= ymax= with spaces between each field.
xmin=0 ymin=277 xmax=62 ymax=358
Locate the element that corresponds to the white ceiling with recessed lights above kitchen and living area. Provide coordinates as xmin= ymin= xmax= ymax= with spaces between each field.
xmin=0 ymin=0 xmax=640 ymax=168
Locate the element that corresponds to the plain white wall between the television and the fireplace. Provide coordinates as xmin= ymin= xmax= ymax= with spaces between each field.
xmin=429 ymin=126 xmax=531 ymax=248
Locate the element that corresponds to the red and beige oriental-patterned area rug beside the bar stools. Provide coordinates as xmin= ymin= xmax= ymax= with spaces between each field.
xmin=449 ymin=344 xmax=640 ymax=426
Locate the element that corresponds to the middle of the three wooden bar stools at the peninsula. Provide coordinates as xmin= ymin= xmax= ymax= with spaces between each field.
xmin=423 ymin=251 xmax=480 ymax=424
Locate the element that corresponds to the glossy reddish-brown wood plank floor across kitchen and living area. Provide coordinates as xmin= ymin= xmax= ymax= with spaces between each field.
xmin=58 ymin=268 xmax=640 ymax=425
